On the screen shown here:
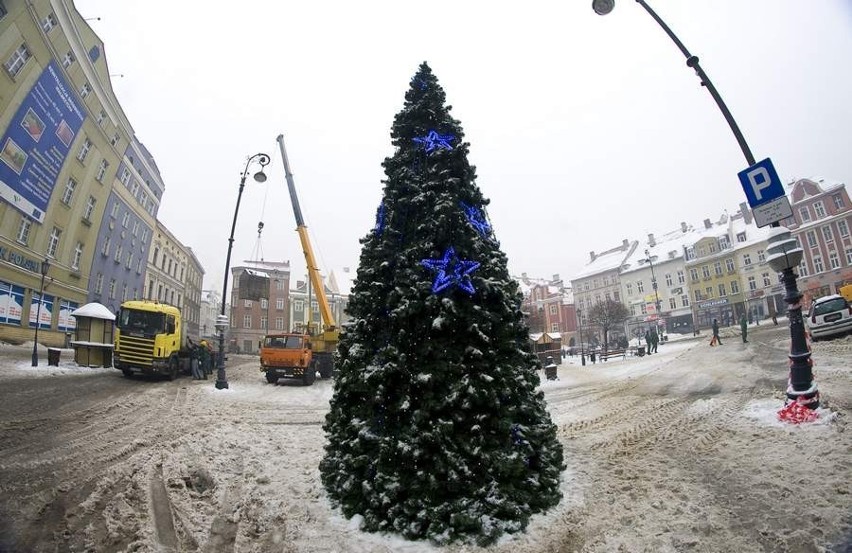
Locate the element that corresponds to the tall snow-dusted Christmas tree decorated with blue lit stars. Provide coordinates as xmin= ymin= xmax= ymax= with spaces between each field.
xmin=320 ymin=63 xmax=564 ymax=545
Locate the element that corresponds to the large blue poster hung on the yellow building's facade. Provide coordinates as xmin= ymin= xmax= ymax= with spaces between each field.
xmin=0 ymin=61 xmax=86 ymax=223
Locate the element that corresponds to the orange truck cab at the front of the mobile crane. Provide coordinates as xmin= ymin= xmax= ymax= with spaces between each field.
xmin=260 ymin=332 xmax=317 ymax=386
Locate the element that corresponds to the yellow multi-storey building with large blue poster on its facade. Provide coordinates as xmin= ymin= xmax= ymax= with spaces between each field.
xmin=0 ymin=0 xmax=127 ymax=345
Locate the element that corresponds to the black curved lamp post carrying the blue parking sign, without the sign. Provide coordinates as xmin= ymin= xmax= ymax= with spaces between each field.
xmin=592 ymin=0 xmax=819 ymax=409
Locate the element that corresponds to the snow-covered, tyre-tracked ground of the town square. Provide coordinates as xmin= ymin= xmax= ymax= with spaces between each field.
xmin=0 ymin=325 xmax=852 ymax=553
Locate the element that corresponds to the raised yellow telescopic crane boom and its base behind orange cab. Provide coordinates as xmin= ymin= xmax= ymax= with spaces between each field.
xmin=277 ymin=134 xmax=340 ymax=378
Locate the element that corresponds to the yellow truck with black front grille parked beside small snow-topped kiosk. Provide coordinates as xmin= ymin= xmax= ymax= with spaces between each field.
xmin=113 ymin=300 xmax=190 ymax=380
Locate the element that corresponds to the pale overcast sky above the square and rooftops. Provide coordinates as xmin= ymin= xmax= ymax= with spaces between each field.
xmin=76 ymin=0 xmax=852 ymax=292
